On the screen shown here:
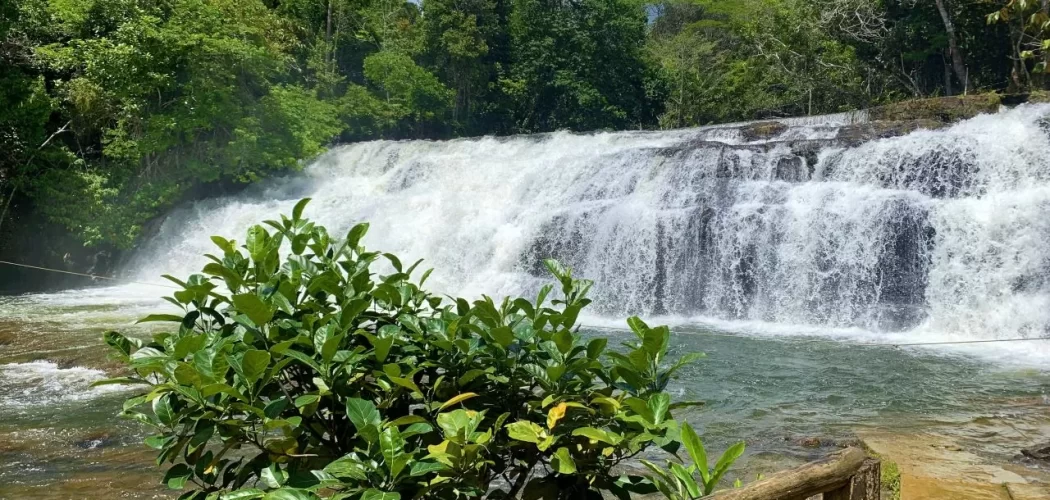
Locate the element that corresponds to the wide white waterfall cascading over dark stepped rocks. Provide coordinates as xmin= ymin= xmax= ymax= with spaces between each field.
xmin=125 ymin=105 xmax=1050 ymax=338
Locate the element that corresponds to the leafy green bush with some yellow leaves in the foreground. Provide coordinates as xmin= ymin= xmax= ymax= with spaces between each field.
xmin=96 ymin=200 xmax=743 ymax=500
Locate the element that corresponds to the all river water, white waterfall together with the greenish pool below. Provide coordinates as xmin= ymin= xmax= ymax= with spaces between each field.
xmin=0 ymin=106 xmax=1050 ymax=498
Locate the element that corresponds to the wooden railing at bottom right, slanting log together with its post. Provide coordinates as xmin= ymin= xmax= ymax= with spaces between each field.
xmin=712 ymin=447 xmax=882 ymax=500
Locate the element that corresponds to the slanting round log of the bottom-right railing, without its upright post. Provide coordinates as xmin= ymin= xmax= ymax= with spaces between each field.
xmin=712 ymin=447 xmax=878 ymax=500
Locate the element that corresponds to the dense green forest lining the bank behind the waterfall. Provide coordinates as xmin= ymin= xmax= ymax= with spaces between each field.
xmin=0 ymin=0 xmax=1050 ymax=281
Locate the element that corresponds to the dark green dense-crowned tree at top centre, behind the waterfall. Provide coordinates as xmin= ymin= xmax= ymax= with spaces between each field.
xmin=501 ymin=0 xmax=663 ymax=132
